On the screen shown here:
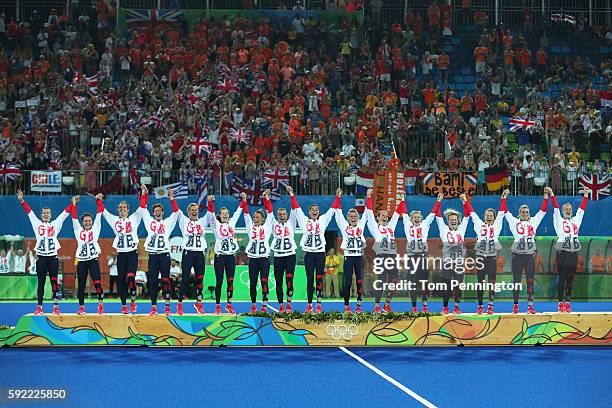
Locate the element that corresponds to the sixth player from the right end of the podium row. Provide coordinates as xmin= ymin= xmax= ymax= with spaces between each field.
xmin=364 ymin=189 xmax=406 ymax=313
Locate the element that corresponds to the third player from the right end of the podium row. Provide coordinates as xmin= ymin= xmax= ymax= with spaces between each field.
xmin=466 ymin=192 xmax=508 ymax=314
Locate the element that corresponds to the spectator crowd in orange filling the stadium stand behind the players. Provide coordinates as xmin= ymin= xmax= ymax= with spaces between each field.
xmin=0 ymin=0 xmax=612 ymax=198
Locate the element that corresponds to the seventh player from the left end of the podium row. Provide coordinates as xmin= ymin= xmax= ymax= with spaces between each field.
xmin=242 ymin=190 xmax=274 ymax=313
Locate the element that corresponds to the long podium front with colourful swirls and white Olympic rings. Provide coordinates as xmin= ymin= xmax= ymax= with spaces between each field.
xmin=0 ymin=312 xmax=612 ymax=347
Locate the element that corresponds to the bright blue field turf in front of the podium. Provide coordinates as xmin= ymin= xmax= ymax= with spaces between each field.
xmin=0 ymin=347 xmax=612 ymax=408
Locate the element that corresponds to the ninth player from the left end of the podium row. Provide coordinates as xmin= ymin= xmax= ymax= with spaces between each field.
xmin=287 ymin=187 xmax=334 ymax=313
